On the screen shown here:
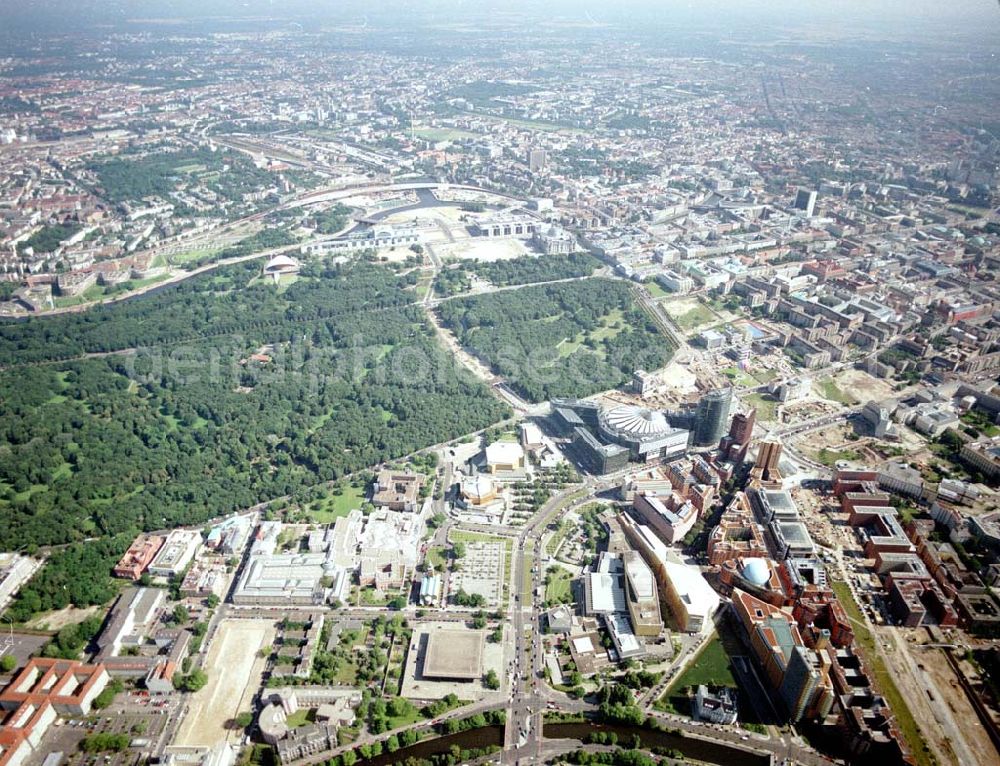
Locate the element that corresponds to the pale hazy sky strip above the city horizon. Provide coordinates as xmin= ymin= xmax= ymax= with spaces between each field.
xmin=0 ymin=0 xmax=1000 ymax=40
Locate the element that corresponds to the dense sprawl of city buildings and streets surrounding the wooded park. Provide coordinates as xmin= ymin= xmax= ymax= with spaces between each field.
xmin=0 ymin=7 xmax=1000 ymax=766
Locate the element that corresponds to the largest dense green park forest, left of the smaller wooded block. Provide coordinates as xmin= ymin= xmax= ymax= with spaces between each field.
xmin=0 ymin=263 xmax=507 ymax=618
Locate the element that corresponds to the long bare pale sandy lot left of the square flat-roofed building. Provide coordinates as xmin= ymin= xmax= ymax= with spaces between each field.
xmin=175 ymin=620 xmax=275 ymax=745
